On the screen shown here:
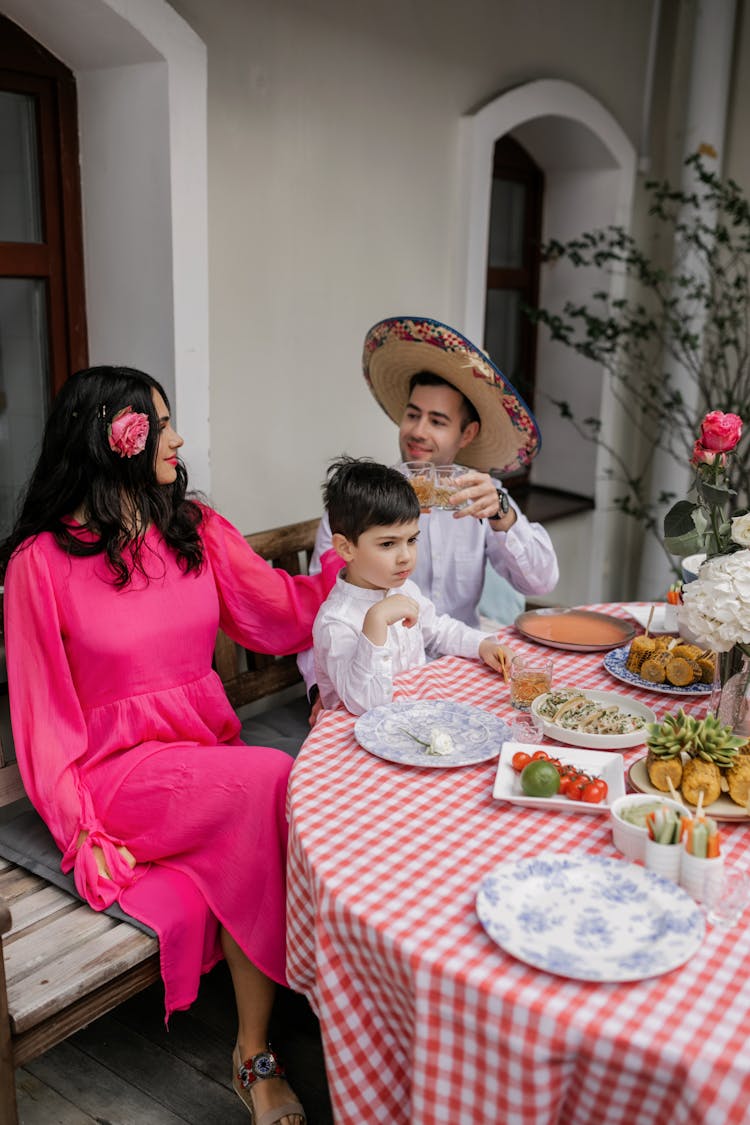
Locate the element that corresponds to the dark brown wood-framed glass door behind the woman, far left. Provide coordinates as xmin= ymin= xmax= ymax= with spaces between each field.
xmin=0 ymin=16 xmax=88 ymax=536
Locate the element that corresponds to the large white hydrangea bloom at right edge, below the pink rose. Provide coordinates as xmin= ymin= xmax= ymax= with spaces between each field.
xmin=677 ymin=550 xmax=750 ymax=653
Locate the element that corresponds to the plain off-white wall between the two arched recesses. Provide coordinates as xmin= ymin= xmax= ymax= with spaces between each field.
xmin=167 ymin=0 xmax=650 ymax=529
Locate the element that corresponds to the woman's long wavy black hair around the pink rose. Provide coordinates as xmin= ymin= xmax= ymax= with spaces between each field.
xmin=0 ymin=367 xmax=204 ymax=586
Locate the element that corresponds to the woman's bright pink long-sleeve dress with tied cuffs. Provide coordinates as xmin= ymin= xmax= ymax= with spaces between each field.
xmin=4 ymin=509 xmax=341 ymax=1015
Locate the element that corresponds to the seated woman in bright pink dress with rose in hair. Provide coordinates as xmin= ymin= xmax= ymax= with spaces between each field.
xmin=0 ymin=367 xmax=341 ymax=1125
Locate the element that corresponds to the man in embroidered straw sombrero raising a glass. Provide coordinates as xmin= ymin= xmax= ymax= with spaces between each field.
xmin=300 ymin=316 xmax=559 ymax=702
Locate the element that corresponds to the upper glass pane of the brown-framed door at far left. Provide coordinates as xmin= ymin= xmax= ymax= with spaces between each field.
xmin=0 ymin=90 xmax=42 ymax=242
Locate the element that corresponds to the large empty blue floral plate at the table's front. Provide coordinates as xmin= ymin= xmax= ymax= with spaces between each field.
xmin=477 ymin=855 xmax=705 ymax=981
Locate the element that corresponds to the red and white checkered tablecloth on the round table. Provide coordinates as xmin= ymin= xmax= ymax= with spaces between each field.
xmin=288 ymin=606 xmax=750 ymax=1125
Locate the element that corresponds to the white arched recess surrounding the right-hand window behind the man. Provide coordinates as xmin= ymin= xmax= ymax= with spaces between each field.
xmin=455 ymin=80 xmax=636 ymax=601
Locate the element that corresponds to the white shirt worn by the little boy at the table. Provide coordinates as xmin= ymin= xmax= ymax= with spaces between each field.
xmin=313 ymin=572 xmax=488 ymax=714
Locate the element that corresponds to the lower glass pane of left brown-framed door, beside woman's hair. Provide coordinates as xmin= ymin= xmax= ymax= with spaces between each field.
xmin=0 ymin=278 xmax=48 ymax=536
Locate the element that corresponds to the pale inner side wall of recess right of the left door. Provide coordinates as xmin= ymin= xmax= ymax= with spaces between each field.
xmin=78 ymin=62 xmax=175 ymax=402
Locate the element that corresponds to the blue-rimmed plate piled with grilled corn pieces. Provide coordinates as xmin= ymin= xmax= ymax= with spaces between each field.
xmin=604 ymin=633 xmax=716 ymax=695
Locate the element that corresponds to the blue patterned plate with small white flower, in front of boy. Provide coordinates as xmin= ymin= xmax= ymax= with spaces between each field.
xmin=354 ymin=700 xmax=510 ymax=770
